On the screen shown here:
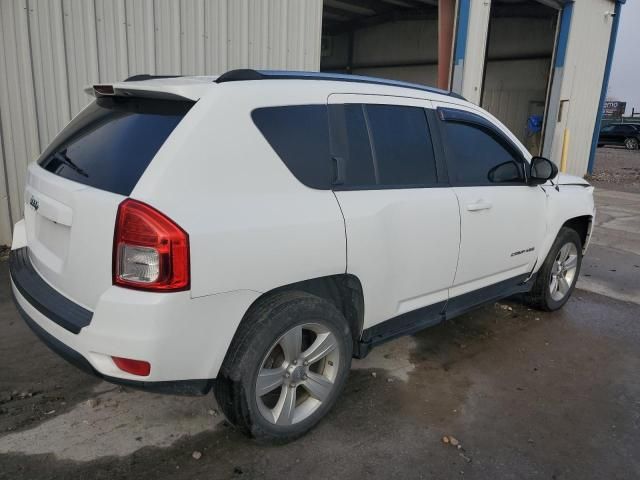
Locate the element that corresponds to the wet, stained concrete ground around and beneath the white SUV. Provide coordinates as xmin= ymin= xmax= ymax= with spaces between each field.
xmin=0 ymin=185 xmax=640 ymax=480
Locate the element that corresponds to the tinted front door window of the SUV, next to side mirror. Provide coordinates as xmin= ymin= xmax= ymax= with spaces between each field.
xmin=442 ymin=116 xmax=525 ymax=186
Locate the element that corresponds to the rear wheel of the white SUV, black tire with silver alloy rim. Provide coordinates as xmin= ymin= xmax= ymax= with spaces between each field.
xmin=214 ymin=292 xmax=353 ymax=443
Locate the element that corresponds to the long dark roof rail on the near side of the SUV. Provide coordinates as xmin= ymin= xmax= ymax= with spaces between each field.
xmin=215 ymin=68 xmax=466 ymax=100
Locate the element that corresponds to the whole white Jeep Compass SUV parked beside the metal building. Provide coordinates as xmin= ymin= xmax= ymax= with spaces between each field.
xmin=10 ymin=70 xmax=594 ymax=440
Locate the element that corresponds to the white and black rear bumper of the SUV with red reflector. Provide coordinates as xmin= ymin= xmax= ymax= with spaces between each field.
xmin=10 ymin=248 xmax=259 ymax=394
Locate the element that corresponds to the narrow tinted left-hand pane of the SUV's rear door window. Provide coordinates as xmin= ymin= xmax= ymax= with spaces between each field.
xmin=329 ymin=103 xmax=376 ymax=186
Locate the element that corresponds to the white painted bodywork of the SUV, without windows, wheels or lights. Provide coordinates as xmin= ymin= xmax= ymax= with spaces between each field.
xmin=12 ymin=74 xmax=594 ymax=381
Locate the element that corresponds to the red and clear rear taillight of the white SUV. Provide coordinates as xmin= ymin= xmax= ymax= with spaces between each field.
xmin=113 ymin=198 xmax=189 ymax=292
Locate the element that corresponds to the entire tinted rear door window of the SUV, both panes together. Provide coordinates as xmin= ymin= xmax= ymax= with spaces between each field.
xmin=329 ymin=104 xmax=437 ymax=189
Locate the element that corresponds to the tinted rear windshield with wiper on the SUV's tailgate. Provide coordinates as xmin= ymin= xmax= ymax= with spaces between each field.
xmin=38 ymin=97 xmax=193 ymax=196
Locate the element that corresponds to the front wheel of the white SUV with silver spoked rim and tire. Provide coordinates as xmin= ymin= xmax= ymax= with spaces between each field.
xmin=527 ymin=227 xmax=582 ymax=312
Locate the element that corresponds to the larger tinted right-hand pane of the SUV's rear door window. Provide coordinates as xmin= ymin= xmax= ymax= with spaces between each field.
xmin=366 ymin=105 xmax=437 ymax=186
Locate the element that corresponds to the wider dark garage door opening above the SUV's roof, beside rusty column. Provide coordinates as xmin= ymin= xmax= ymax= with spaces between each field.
xmin=320 ymin=0 xmax=444 ymax=88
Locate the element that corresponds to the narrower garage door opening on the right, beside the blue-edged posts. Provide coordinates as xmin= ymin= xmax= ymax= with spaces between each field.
xmin=481 ymin=0 xmax=559 ymax=155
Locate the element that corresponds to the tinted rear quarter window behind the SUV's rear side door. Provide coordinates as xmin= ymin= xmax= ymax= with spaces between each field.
xmin=251 ymin=105 xmax=332 ymax=189
